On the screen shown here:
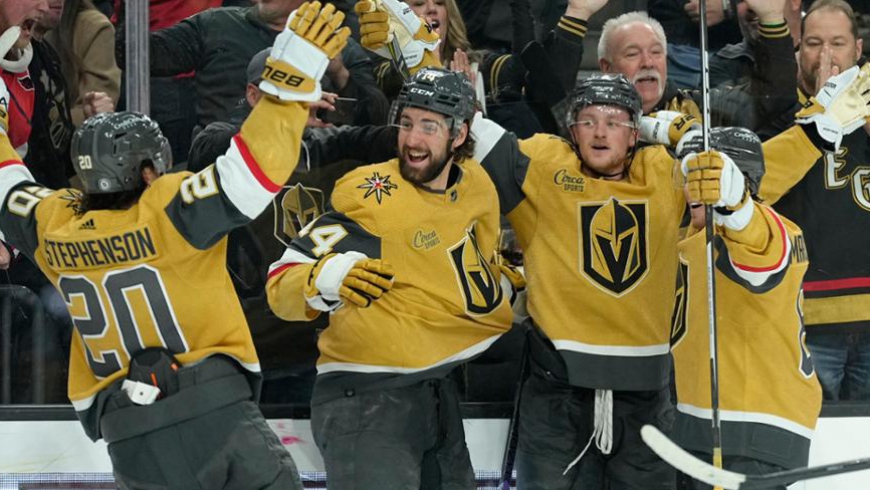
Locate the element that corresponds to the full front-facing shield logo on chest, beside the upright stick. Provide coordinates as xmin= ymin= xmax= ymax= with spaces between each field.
xmin=580 ymin=198 xmax=648 ymax=297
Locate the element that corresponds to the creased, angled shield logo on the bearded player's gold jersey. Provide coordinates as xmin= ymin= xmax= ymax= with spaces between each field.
xmin=447 ymin=225 xmax=502 ymax=316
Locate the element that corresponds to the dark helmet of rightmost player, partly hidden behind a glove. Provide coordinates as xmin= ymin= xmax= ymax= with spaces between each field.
xmin=677 ymin=127 xmax=764 ymax=196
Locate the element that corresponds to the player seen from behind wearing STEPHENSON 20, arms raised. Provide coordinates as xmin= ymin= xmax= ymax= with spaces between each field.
xmin=0 ymin=2 xmax=349 ymax=489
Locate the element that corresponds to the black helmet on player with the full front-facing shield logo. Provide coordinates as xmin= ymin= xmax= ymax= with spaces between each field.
xmin=565 ymin=73 xmax=643 ymax=127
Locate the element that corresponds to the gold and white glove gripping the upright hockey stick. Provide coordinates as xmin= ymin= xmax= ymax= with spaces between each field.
xmin=682 ymin=150 xmax=753 ymax=231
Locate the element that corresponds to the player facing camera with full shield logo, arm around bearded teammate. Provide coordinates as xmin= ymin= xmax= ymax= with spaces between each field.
xmin=472 ymin=75 xmax=685 ymax=490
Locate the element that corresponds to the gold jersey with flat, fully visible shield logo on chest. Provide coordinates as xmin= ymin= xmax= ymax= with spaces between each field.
xmin=472 ymin=120 xmax=686 ymax=390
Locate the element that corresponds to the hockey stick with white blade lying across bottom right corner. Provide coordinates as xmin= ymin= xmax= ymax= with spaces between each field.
xmin=640 ymin=425 xmax=870 ymax=490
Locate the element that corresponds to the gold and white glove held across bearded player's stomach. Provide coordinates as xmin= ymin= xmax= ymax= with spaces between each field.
xmin=305 ymin=252 xmax=393 ymax=311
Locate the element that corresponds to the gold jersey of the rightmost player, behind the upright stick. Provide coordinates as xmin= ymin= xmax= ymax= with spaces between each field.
xmin=672 ymin=203 xmax=822 ymax=467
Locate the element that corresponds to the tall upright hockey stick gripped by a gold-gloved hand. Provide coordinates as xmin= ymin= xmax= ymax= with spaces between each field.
xmin=698 ymin=0 xmax=722 ymax=482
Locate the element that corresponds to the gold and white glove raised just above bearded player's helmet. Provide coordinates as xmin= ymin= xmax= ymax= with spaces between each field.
xmin=354 ymin=0 xmax=440 ymax=68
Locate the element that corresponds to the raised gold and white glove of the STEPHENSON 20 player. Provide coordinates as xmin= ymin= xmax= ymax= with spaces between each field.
xmin=260 ymin=2 xmax=350 ymax=102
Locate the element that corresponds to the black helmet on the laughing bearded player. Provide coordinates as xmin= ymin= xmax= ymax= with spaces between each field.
xmin=390 ymin=68 xmax=475 ymax=138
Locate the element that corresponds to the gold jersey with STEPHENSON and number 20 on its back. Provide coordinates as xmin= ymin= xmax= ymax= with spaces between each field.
xmin=0 ymin=97 xmax=308 ymax=437
